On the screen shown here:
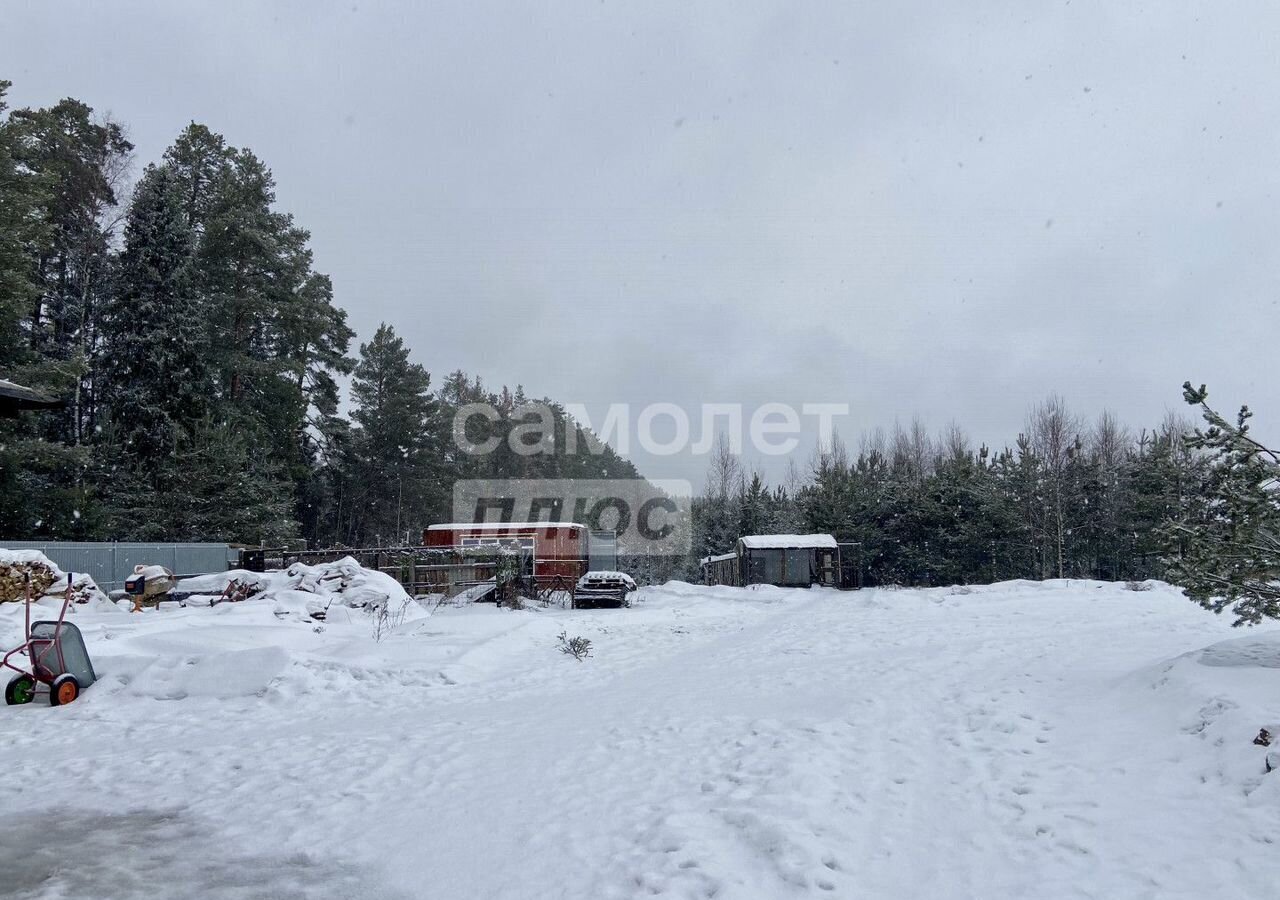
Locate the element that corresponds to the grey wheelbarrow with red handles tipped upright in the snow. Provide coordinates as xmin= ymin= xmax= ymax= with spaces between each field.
xmin=0 ymin=575 xmax=97 ymax=707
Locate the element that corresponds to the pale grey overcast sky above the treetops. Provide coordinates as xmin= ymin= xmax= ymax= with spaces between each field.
xmin=0 ymin=0 xmax=1280 ymax=486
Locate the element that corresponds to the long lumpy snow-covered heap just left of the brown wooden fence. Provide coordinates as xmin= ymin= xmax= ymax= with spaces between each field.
xmin=178 ymin=556 xmax=412 ymax=613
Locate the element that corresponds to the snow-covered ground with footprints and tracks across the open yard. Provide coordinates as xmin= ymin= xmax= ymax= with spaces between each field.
xmin=0 ymin=583 xmax=1280 ymax=900
